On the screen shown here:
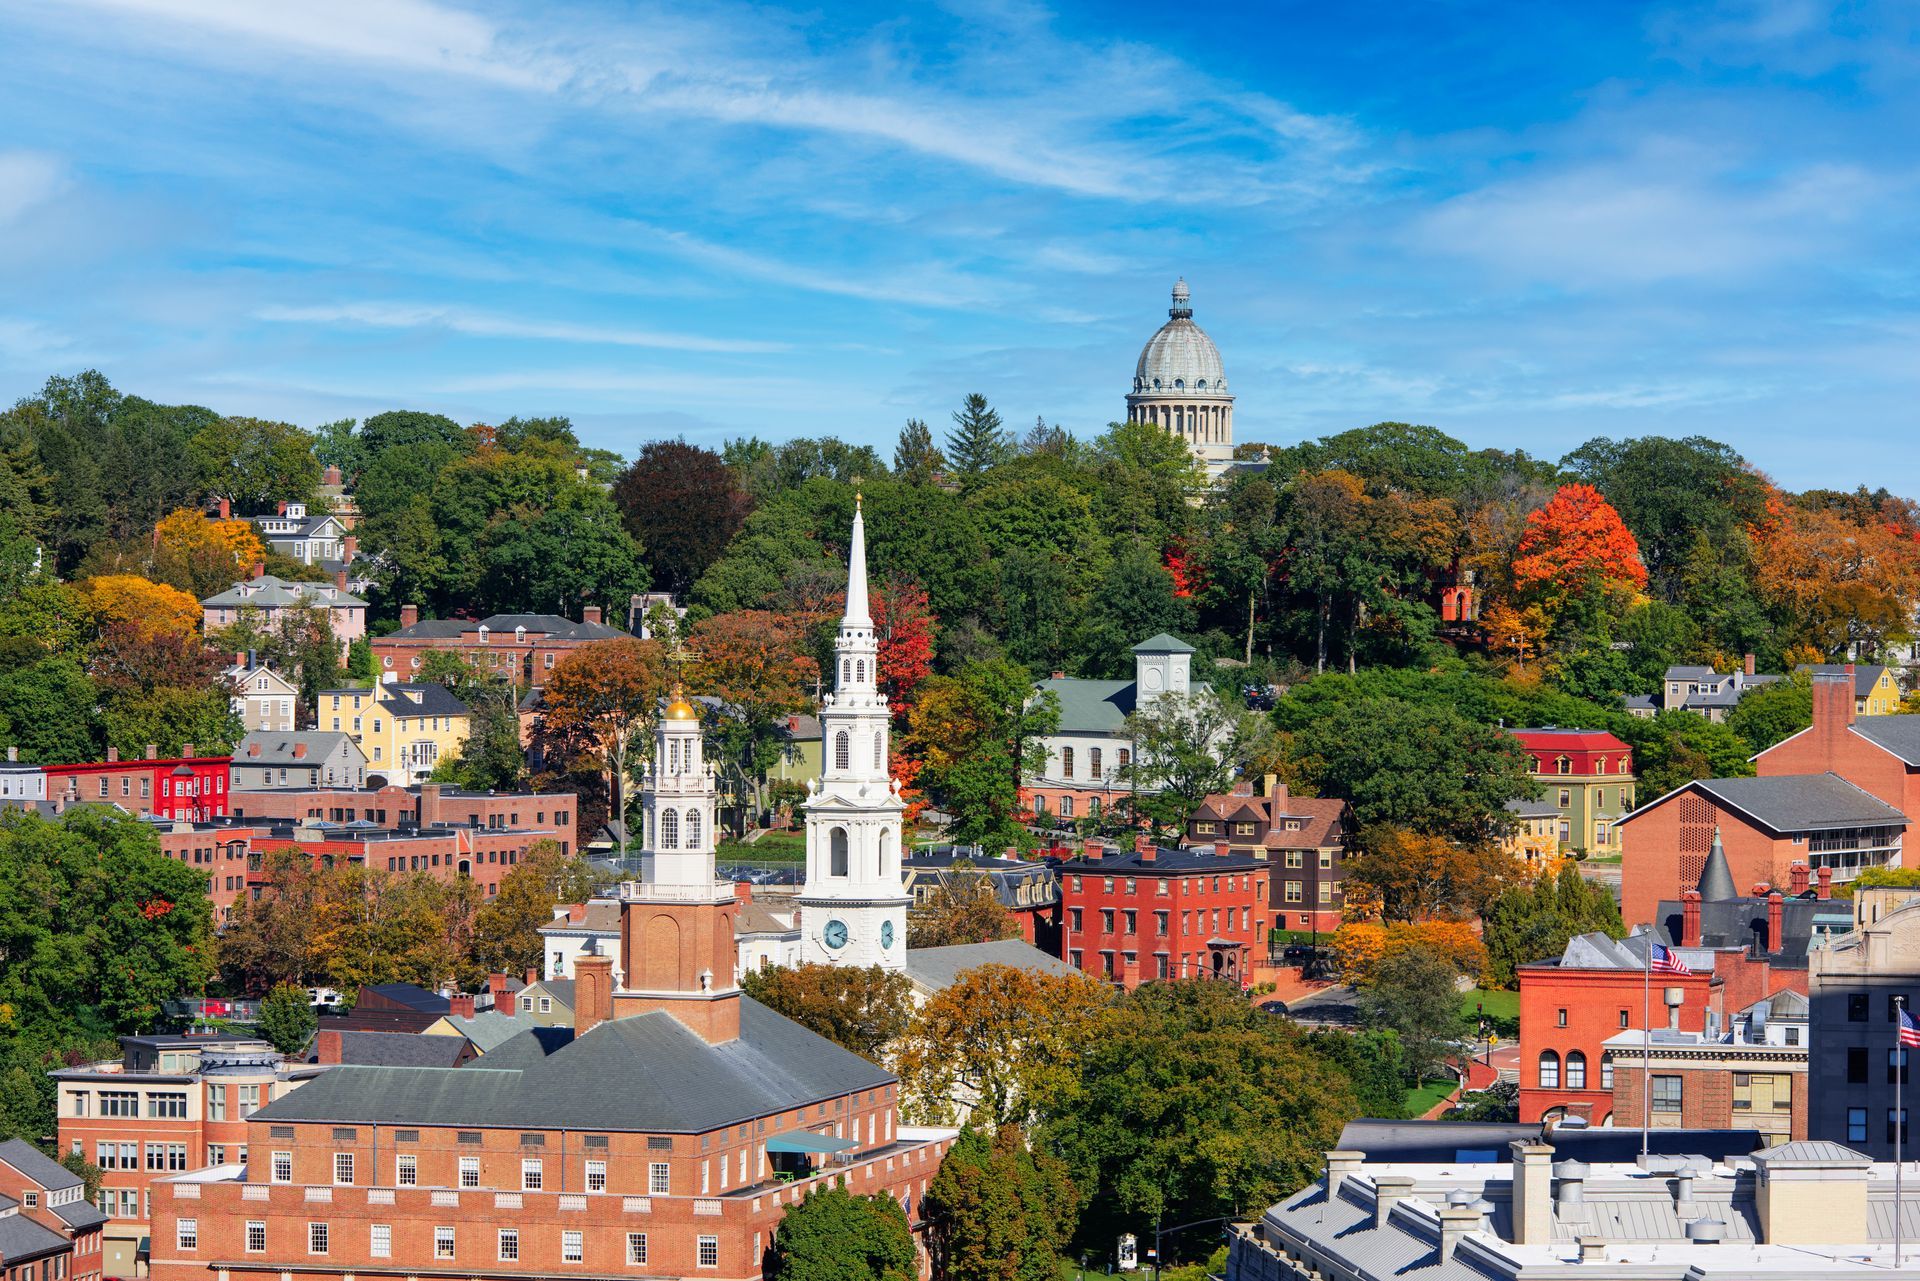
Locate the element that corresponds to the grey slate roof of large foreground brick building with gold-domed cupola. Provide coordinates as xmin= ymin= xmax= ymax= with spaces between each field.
xmin=253 ymin=997 xmax=895 ymax=1133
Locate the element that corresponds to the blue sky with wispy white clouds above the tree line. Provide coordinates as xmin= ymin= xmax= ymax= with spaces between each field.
xmin=0 ymin=0 xmax=1920 ymax=495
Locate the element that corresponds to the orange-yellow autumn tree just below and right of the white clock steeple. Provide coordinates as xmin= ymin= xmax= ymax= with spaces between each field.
xmin=897 ymin=964 xmax=1114 ymax=1125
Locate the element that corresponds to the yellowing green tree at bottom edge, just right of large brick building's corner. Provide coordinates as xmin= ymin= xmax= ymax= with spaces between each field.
xmin=920 ymin=1125 xmax=1079 ymax=1281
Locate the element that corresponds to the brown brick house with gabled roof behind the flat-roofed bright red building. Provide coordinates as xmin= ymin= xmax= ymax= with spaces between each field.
xmin=1185 ymin=776 xmax=1354 ymax=943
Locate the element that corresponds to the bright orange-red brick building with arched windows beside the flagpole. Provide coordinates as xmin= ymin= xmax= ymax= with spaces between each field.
xmin=1519 ymin=933 xmax=1713 ymax=1125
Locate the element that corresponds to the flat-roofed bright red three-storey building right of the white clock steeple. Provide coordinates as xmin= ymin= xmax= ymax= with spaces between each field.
xmin=1056 ymin=835 xmax=1271 ymax=991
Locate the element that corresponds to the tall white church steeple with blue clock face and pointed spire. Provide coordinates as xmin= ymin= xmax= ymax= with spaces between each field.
xmin=799 ymin=499 xmax=908 ymax=970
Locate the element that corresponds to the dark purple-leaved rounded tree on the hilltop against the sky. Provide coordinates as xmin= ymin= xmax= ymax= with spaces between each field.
xmin=612 ymin=440 xmax=753 ymax=595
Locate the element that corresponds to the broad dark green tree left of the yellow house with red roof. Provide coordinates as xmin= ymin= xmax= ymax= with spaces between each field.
xmin=1279 ymin=695 xmax=1536 ymax=843
